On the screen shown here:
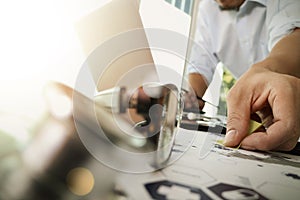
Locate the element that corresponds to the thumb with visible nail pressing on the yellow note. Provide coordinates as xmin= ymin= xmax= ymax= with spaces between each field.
xmin=224 ymin=88 xmax=251 ymax=147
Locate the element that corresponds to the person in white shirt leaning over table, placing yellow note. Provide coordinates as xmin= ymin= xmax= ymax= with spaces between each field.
xmin=188 ymin=0 xmax=300 ymax=151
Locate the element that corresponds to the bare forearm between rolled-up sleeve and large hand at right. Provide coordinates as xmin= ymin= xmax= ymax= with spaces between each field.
xmin=254 ymin=28 xmax=300 ymax=78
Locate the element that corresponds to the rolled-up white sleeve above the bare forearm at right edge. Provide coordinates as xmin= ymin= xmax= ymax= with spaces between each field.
xmin=266 ymin=0 xmax=300 ymax=51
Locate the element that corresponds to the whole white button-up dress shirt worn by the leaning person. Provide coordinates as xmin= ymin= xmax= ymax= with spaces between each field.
xmin=188 ymin=0 xmax=300 ymax=83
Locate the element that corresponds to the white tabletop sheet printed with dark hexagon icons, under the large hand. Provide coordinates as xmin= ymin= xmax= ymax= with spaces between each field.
xmin=117 ymin=129 xmax=300 ymax=200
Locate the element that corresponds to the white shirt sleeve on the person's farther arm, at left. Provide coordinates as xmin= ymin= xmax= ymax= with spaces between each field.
xmin=187 ymin=0 xmax=218 ymax=83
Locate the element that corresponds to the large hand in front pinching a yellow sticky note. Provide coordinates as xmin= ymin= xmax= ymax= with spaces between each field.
xmin=225 ymin=65 xmax=300 ymax=151
